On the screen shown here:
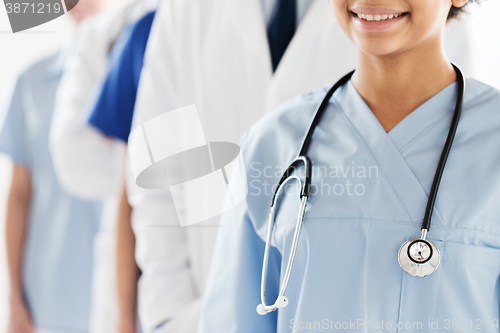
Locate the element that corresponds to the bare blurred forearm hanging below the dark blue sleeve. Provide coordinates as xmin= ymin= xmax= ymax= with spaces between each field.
xmin=116 ymin=182 xmax=140 ymax=333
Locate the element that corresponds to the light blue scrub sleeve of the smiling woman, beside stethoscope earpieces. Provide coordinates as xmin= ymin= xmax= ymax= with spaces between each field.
xmin=198 ymin=198 xmax=281 ymax=333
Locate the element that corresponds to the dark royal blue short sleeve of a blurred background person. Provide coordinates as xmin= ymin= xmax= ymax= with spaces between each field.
xmin=89 ymin=12 xmax=155 ymax=142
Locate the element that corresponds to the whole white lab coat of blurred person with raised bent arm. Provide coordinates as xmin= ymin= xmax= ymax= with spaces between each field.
xmin=50 ymin=1 xmax=158 ymax=333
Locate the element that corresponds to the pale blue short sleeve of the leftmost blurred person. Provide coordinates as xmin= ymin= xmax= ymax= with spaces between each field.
xmin=0 ymin=76 xmax=29 ymax=166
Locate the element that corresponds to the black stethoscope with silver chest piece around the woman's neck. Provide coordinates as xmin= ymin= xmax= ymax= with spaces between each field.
xmin=257 ymin=64 xmax=465 ymax=315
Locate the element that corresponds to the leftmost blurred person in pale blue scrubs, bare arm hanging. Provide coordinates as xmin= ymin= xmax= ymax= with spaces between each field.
xmin=0 ymin=0 xmax=101 ymax=333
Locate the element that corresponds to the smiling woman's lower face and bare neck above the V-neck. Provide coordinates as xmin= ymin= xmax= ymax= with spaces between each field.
xmin=332 ymin=0 xmax=474 ymax=132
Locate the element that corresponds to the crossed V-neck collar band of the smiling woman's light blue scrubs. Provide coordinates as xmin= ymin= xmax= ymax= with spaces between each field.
xmin=332 ymin=82 xmax=456 ymax=225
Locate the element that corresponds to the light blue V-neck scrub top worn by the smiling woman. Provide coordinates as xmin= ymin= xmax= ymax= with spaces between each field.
xmin=199 ymin=79 xmax=500 ymax=333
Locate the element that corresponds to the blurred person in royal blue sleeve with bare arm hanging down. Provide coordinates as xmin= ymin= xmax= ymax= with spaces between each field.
xmin=88 ymin=11 xmax=155 ymax=333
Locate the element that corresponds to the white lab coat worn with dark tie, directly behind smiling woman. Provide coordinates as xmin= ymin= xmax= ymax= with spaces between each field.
xmin=129 ymin=0 xmax=475 ymax=333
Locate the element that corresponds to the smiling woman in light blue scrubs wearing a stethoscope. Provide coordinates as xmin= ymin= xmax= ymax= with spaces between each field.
xmin=200 ymin=0 xmax=500 ymax=333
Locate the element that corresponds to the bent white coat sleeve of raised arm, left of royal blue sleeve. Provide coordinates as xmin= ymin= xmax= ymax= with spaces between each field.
xmin=50 ymin=0 xmax=157 ymax=199
